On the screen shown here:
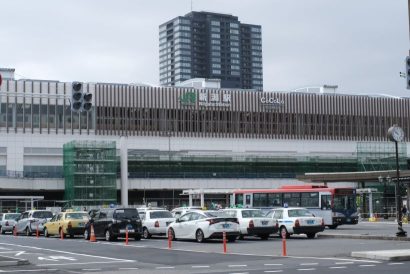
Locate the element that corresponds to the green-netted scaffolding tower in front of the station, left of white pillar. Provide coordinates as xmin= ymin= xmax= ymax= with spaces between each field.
xmin=63 ymin=141 xmax=117 ymax=206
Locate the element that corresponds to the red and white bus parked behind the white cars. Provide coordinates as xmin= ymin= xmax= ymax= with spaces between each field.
xmin=231 ymin=185 xmax=359 ymax=229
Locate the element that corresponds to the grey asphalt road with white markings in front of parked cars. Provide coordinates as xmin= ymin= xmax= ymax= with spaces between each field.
xmin=0 ymin=223 xmax=410 ymax=273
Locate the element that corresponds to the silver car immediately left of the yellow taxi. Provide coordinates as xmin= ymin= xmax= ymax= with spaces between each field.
xmin=14 ymin=210 xmax=53 ymax=236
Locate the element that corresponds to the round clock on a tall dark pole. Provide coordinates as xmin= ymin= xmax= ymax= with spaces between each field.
xmin=387 ymin=125 xmax=407 ymax=237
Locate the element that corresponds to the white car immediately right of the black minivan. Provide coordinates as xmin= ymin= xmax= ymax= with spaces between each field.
xmin=140 ymin=209 xmax=175 ymax=239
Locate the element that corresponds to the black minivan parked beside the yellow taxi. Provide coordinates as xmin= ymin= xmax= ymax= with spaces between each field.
xmin=84 ymin=208 xmax=142 ymax=241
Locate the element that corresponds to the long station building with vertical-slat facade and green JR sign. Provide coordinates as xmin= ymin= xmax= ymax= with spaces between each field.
xmin=0 ymin=77 xmax=410 ymax=210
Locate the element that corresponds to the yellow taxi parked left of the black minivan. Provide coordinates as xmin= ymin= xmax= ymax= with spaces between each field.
xmin=44 ymin=211 xmax=89 ymax=238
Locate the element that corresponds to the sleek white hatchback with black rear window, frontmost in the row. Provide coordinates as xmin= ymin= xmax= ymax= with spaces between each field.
xmin=168 ymin=210 xmax=239 ymax=243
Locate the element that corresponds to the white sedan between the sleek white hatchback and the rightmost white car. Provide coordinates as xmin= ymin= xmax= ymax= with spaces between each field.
xmin=223 ymin=208 xmax=279 ymax=240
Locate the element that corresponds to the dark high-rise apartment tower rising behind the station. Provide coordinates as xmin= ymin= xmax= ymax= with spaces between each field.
xmin=159 ymin=12 xmax=263 ymax=90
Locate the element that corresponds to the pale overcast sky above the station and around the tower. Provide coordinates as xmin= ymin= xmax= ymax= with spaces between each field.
xmin=0 ymin=0 xmax=410 ymax=96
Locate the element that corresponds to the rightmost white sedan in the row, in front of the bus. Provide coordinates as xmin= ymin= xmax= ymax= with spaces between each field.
xmin=267 ymin=207 xmax=325 ymax=239
